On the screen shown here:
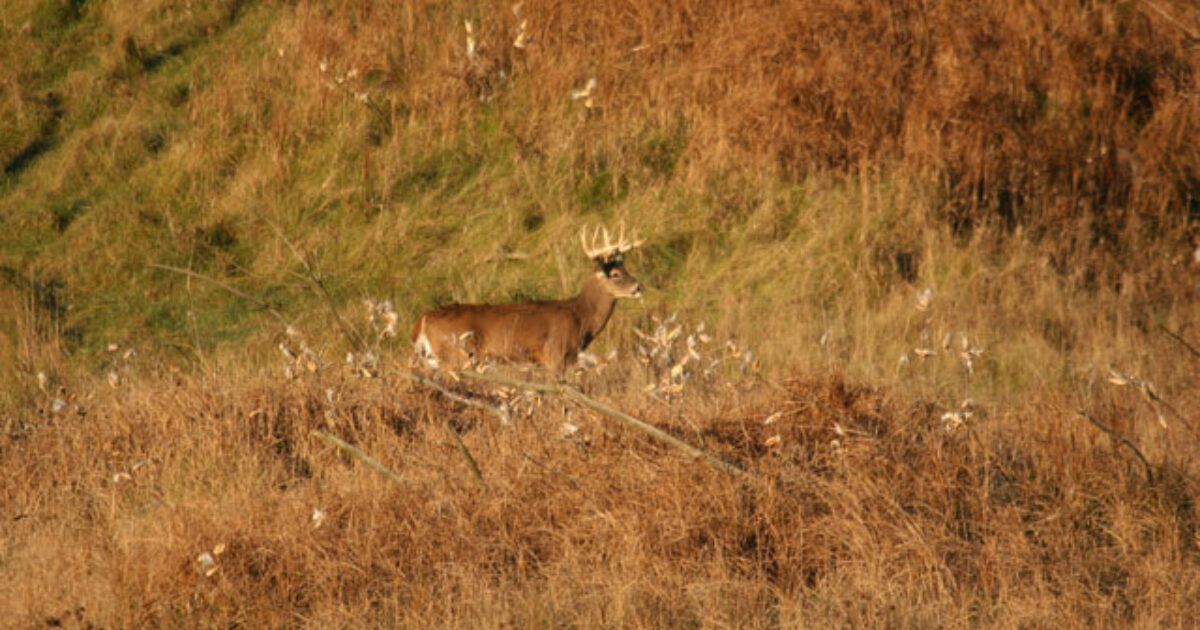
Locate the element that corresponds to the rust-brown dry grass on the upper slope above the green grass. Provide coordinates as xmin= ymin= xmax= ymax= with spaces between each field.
xmin=276 ymin=0 xmax=1200 ymax=225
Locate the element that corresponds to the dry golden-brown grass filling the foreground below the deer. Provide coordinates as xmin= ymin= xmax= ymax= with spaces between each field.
xmin=0 ymin=355 xmax=1200 ymax=626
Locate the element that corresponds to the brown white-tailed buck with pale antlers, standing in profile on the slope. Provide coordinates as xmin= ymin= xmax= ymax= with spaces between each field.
xmin=413 ymin=226 xmax=643 ymax=372
